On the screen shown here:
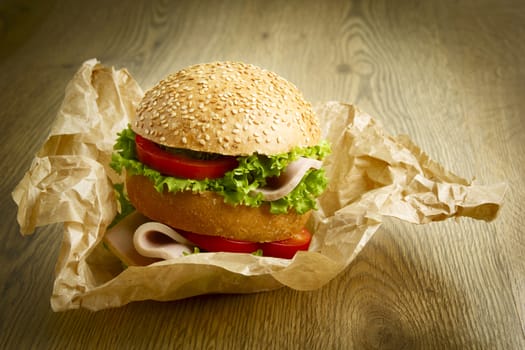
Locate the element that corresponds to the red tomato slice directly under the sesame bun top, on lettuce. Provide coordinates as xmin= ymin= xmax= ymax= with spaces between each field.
xmin=135 ymin=134 xmax=238 ymax=180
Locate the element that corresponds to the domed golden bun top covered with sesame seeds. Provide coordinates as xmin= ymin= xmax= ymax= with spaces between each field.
xmin=131 ymin=62 xmax=321 ymax=155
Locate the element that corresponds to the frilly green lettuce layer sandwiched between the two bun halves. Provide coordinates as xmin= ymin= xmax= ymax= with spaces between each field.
xmin=111 ymin=127 xmax=330 ymax=214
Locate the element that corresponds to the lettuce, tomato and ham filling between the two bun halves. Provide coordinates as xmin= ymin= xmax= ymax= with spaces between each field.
xmin=111 ymin=127 xmax=330 ymax=214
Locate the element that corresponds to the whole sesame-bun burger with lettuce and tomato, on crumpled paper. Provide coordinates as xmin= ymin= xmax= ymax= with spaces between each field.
xmin=111 ymin=62 xmax=330 ymax=257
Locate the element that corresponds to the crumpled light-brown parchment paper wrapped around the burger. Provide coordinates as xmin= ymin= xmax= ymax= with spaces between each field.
xmin=12 ymin=59 xmax=506 ymax=311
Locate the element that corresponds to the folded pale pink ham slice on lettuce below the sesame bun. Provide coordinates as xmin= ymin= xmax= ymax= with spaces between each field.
xmin=253 ymin=157 xmax=323 ymax=201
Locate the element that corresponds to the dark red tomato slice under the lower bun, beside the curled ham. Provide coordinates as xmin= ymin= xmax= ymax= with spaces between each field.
xmin=179 ymin=231 xmax=259 ymax=253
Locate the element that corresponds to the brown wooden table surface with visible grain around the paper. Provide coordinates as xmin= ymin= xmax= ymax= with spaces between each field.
xmin=0 ymin=0 xmax=525 ymax=349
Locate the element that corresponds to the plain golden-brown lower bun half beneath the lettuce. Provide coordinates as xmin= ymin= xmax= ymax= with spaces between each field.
xmin=126 ymin=175 xmax=310 ymax=242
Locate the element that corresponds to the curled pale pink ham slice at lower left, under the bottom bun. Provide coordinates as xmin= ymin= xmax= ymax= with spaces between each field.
xmin=133 ymin=222 xmax=192 ymax=260
